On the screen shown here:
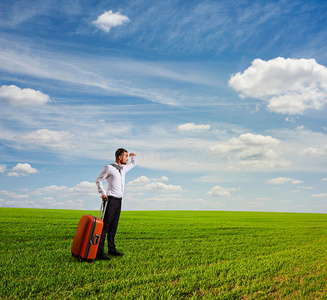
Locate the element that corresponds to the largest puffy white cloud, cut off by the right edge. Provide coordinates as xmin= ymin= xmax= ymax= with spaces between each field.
xmin=228 ymin=57 xmax=327 ymax=115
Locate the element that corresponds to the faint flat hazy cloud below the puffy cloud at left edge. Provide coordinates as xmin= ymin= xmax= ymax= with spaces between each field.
xmin=16 ymin=129 xmax=75 ymax=150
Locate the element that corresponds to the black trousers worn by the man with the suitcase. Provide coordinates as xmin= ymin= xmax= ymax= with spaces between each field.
xmin=98 ymin=196 xmax=122 ymax=254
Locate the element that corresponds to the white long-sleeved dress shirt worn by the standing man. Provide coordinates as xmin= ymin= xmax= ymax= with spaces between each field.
xmin=96 ymin=156 xmax=137 ymax=198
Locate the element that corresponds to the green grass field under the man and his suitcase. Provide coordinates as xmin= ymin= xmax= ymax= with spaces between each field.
xmin=0 ymin=208 xmax=327 ymax=299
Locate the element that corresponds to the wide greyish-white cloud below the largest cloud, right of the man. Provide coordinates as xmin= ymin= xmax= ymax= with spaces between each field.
xmin=210 ymin=133 xmax=290 ymax=168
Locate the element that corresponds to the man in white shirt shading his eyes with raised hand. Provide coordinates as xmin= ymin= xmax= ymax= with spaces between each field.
xmin=96 ymin=148 xmax=136 ymax=260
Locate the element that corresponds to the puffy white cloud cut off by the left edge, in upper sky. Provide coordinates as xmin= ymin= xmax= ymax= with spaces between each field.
xmin=0 ymin=85 xmax=50 ymax=106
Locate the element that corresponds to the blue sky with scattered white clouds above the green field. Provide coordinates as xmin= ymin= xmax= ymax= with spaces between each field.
xmin=0 ymin=0 xmax=327 ymax=213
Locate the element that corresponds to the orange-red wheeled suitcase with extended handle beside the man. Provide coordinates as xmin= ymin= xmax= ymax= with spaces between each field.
xmin=71 ymin=201 xmax=108 ymax=262
